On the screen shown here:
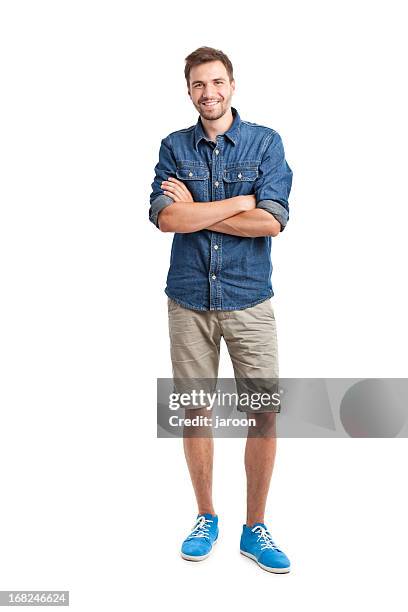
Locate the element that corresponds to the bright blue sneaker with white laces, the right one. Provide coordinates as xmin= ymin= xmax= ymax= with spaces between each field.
xmin=240 ymin=523 xmax=290 ymax=574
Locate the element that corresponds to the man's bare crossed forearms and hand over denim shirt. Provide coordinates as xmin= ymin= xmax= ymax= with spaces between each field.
xmin=159 ymin=177 xmax=281 ymax=238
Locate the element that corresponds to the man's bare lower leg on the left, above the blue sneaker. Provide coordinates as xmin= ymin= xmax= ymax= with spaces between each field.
xmin=183 ymin=409 xmax=216 ymax=514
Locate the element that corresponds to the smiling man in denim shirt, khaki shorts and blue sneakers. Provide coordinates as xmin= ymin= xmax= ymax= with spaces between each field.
xmin=149 ymin=47 xmax=292 ymax=573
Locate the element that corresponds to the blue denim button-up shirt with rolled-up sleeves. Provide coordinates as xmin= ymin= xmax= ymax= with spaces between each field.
xmin=149 ymin=108 xmax=292 ymax=310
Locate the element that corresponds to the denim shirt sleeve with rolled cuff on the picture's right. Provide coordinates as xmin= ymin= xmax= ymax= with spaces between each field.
xmin=254 ymin=132 xmax=293 ymax=231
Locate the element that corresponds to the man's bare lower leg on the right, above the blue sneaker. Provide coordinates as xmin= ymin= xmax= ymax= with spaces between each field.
xmin=245 ymin=413 xmax=276 ymax=527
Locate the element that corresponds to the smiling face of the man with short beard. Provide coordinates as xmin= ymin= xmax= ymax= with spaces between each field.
xmin=188 ymin=60 xmax=235 ymax=121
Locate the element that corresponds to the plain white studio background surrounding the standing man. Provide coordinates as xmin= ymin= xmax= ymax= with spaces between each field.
xmin=0 ymin=0 xmax=408 ymax=612
